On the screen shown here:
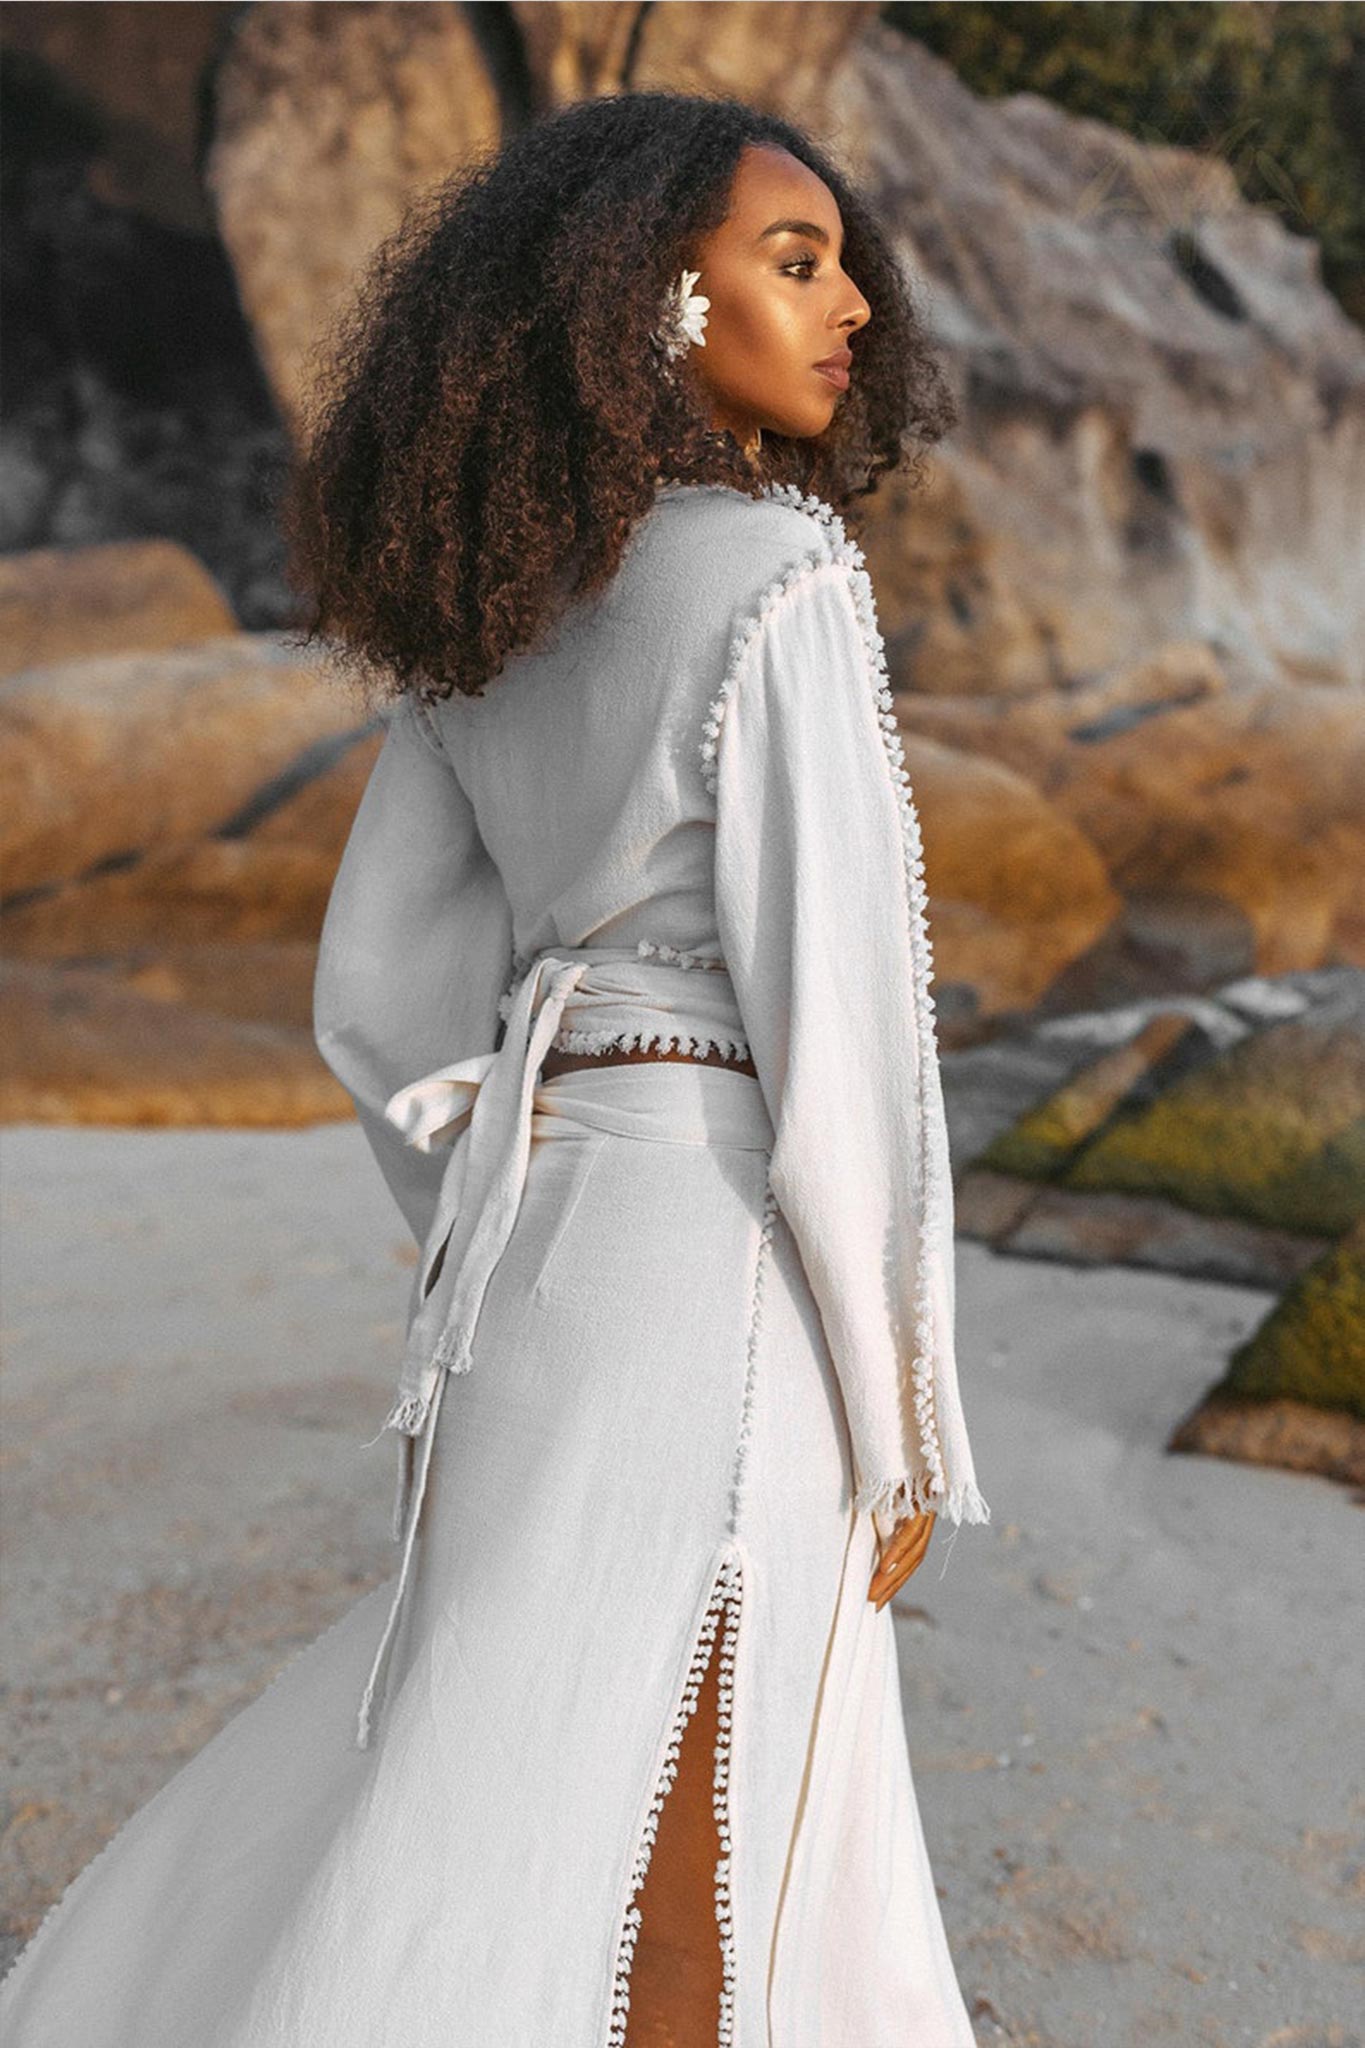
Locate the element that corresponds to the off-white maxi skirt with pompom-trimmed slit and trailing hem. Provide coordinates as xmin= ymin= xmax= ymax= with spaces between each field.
xmin=0 ymin=1061 xmax=972 ymax=2048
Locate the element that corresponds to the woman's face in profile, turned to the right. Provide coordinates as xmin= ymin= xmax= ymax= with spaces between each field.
xmin=684 ymin=143 xmax=872 ymax=453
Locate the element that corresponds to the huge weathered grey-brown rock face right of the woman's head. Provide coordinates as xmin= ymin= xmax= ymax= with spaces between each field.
xmin=834 ymin=24 xmax=1365 ymax=694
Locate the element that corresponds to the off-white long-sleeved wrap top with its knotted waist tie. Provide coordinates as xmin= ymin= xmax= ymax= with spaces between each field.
xmin=315 ymin=483 xmax=990 ymax=1739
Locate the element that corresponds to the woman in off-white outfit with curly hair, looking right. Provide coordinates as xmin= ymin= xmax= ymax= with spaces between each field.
xmin=0 ymin=94 xmax=988 ymax=2048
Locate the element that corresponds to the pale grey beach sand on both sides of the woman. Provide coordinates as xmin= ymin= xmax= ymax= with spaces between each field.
xmin=0 ymin=1124 xmax=1365 ymax=2048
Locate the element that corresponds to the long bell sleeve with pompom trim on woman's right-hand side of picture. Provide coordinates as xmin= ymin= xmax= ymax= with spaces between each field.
xmin=702 ymin=549 xmax=990 ymax=1526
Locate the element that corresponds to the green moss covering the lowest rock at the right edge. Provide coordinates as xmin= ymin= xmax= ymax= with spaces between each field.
xmin=1218 ymin=1229 xmax=1365 ymax=1421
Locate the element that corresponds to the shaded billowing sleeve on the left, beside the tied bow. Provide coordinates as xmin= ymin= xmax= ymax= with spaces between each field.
xmin=313 ymin=696 xmax=512 ymax=1245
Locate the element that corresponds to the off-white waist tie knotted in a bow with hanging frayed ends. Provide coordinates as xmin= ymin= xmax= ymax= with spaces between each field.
xmin=356 ymin=946 xmax=757 ymax=1749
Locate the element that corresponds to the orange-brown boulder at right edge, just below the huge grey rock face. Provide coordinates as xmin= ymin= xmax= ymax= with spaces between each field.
xmin=896 ymin=643 xmax=1365 ymax=981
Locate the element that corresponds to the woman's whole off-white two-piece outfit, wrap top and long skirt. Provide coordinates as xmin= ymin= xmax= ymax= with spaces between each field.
xmin=0 ymin=485 xmax=988 ymax=2048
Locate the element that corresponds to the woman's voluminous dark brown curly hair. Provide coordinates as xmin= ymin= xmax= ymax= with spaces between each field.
xmin=280 ymin=92 xmax=956 ymax=698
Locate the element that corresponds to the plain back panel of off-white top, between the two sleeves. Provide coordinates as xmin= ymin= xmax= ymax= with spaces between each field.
xmin=432 ymin=485 xmax=827 ymax=973
